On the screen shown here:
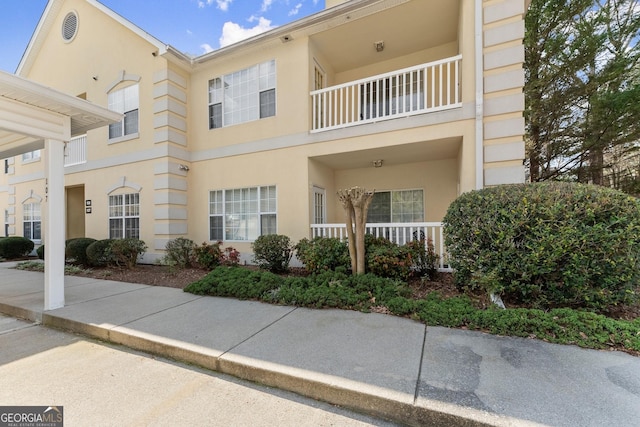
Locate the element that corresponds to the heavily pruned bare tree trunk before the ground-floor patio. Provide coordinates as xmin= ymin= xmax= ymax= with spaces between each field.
xmin=338 ymin=187 xmax=375 ymax=274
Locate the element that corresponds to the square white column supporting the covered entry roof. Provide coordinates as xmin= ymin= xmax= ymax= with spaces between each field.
xmin=43 ymin=139 xmax=66 ymax=310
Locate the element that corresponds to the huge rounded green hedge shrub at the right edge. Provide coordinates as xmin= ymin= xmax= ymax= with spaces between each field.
xmin=444 ymin=182 xmax=640 ymax=310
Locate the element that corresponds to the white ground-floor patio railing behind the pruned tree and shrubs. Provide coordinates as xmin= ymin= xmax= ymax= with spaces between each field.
xmin=311 ymin=222 xmax=451 ymax=271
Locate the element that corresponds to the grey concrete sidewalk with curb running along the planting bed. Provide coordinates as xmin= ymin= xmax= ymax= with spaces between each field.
xmin=0 ymin=263 xmax=640 ymax=426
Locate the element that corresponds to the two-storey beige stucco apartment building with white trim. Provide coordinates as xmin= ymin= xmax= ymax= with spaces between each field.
xmin=0 ymin=0 xmax=528 ymax=262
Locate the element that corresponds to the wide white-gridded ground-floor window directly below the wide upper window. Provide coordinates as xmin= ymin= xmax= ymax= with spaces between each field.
xmin=209 ymin=185 xmax=277 ymax=241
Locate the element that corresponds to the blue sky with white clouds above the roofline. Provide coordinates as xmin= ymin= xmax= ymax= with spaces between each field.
xmin=0 ymin=0 xmax=324 ymax=73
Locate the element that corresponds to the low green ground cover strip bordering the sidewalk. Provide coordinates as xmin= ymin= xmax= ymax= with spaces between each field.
xmin=184 ymin=267 xmax=640 ymax=354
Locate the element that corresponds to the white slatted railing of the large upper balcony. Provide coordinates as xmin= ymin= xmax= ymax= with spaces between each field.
xmin=311 ymin=55 xmax=462 ymax=132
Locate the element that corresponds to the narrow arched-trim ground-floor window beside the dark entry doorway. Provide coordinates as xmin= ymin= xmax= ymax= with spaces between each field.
xmin=109 ymin=193 xmax=140 ymax=239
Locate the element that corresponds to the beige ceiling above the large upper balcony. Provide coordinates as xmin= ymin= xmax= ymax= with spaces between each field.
xmin=311 ymin=0 xmax=460 ymax=73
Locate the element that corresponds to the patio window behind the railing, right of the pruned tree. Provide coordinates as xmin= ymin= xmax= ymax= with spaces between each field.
xmin=367 ymin=190 xmax=424 ymax=223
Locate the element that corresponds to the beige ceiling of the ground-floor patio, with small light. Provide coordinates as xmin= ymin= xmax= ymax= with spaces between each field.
xmin=311 ymin=137 xmax=462 ymax=170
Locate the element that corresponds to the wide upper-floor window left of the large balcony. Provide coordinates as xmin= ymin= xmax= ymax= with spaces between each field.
xmin=209 ymin=60 xmax=276 ymax=129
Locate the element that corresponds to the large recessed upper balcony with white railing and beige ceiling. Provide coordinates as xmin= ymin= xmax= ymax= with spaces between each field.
xmin=310 ymin=0 xmax=462 ymax=132
